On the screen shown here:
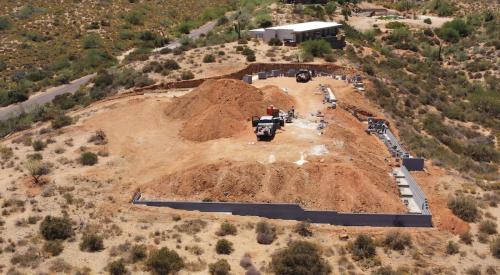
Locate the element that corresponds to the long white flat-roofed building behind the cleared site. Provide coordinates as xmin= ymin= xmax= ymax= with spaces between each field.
xmin=249 ymin=21 xmax=342 ymax=43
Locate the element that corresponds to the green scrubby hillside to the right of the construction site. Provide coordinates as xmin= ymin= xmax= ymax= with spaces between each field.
xmin=345 ymin=7 xmax=500 ymax=181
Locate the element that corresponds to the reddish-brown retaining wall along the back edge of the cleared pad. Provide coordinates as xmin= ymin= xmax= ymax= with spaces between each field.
xmin=133 ymin=63 xmax=350 ymax=92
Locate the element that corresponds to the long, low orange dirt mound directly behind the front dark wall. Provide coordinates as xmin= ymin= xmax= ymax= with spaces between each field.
xmin=146 ymin=161 xmax=404 ymax=212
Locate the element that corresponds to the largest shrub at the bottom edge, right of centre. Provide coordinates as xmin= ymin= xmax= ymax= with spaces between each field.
xmin=271 ymin=241 xmax=331 ymax=275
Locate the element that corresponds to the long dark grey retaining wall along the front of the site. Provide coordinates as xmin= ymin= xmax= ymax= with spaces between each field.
xmin=132 ymin=194 xmax=432 ymax=227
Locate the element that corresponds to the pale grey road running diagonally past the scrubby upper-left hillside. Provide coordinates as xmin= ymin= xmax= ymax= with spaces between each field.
xmin=0 ymin=21 xmax=217 ymax=120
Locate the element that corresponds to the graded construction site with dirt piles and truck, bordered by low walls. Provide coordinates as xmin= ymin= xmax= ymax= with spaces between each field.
xmin=105 ymin=66 xmax=432 ymax=226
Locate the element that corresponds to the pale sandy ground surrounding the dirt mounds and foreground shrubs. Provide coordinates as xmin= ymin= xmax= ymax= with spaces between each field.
xmin=0 ymin=76 xmax=499 ymax=274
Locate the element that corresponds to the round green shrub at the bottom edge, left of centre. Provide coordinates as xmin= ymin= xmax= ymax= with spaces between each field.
xmin=146 ymin=247 xmax=184 ymax=275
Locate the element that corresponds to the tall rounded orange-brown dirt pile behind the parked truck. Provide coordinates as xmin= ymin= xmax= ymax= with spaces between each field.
xmin=165 ymin=79 xmax=294 ymax=141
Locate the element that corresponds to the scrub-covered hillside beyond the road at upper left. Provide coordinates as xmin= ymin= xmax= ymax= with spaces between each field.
xmin=0 ymin=0 xmax=234 ymax=106
